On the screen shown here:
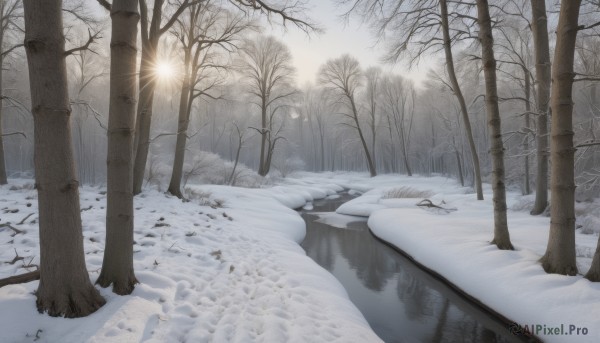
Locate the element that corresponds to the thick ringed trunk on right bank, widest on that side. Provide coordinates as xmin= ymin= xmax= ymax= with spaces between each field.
xmin=541 ymin=0 xmax=581 ymax=275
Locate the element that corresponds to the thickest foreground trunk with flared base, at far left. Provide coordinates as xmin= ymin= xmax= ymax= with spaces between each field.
xmin=23 ymin=0 xmax=105 ymax=317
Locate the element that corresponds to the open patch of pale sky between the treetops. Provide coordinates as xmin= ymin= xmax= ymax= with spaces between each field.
xmin=265 ymin=0 xmax=426 ymax=85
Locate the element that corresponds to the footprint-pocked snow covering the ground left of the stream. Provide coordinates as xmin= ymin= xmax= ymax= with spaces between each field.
xmin=0 ymin=180 xmax=380 ymax=343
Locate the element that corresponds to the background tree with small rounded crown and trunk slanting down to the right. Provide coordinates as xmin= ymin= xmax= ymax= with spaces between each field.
xmin=319 ymin=55 xmax=377 ymax=177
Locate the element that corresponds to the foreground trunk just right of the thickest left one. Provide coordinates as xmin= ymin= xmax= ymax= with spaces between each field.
xmin=96 ymin=0 xmax=140 ymax=295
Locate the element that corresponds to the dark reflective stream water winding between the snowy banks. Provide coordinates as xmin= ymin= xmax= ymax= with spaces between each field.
xmin=302 ymin=196 xmax=536 ymax=343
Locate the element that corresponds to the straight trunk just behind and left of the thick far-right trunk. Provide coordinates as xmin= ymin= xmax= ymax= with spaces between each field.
xmin=531 ymin=0 xmax=551 ymax=215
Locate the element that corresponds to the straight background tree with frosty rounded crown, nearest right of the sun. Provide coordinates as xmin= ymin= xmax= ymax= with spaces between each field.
xmin=240 ymin=36 xmax=297 ymax=176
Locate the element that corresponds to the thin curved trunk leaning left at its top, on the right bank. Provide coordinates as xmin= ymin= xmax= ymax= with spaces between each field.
xmin=440 ymin=0 xmax=483 ymax=200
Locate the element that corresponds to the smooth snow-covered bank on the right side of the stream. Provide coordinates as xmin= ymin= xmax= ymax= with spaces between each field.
xmin=330 ymin=177 xmax=600 ymax=342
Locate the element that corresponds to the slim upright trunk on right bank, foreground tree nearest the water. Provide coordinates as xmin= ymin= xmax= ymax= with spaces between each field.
xmin=477 ymin=0 xmax=513 ymax=250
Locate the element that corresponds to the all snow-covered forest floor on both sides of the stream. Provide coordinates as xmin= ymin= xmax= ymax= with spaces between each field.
xmin=0 ymin=173 xmax=600 ymax=342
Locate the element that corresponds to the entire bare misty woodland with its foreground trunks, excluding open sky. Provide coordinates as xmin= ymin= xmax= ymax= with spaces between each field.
xmin=0 ymin=0 xmax=600 ymax=342
